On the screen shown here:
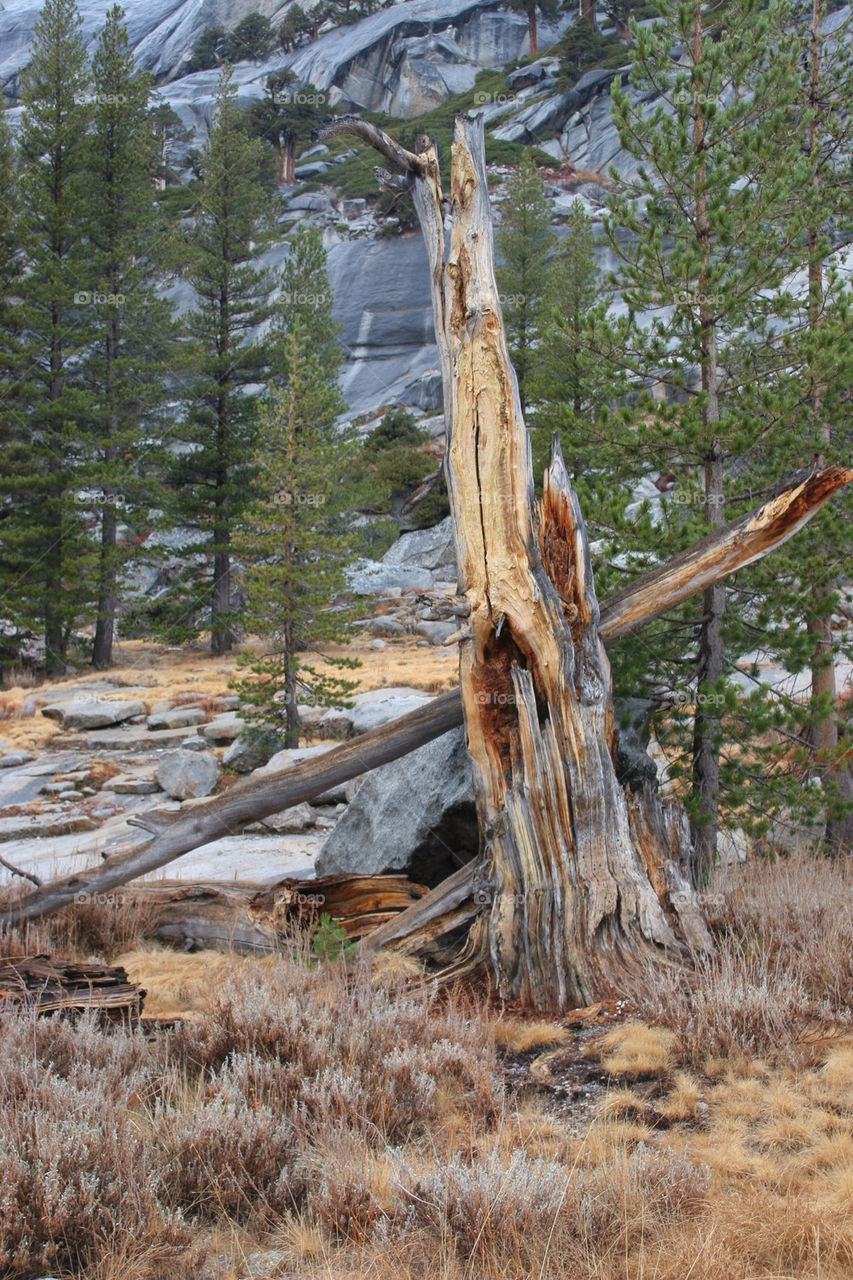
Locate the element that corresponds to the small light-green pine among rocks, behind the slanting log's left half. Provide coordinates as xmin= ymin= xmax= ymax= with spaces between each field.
xmin=237 ymin=229 xmax=357 ymax=746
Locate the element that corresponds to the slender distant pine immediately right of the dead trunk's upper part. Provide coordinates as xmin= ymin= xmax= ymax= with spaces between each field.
xmin=496 ymin=155 xmax=556 ymax=408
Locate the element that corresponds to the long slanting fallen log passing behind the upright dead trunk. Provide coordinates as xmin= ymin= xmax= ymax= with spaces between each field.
xmin=0 ymin=466 xmax=853 ymax=927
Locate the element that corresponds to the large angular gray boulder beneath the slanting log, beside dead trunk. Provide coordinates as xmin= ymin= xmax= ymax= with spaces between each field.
xmin=316 ymin=728 xmax=479 ymax=886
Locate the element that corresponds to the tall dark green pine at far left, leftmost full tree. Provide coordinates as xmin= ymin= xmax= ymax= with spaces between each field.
xmin=0 ymin=0 xmax=92 ymax=672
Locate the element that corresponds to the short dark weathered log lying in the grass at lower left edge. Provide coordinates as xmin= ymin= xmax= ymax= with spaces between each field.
xmin=0 ymin=955 xmax=145 ymax=1021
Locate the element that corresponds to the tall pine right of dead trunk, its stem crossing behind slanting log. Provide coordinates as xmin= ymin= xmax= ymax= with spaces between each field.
xmin=594 ymin=0 xmax=802 ymax=883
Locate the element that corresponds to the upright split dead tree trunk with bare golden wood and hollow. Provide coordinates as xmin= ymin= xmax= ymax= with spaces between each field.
xmin=416 ymin=116 xmax=711 ymax=1010
